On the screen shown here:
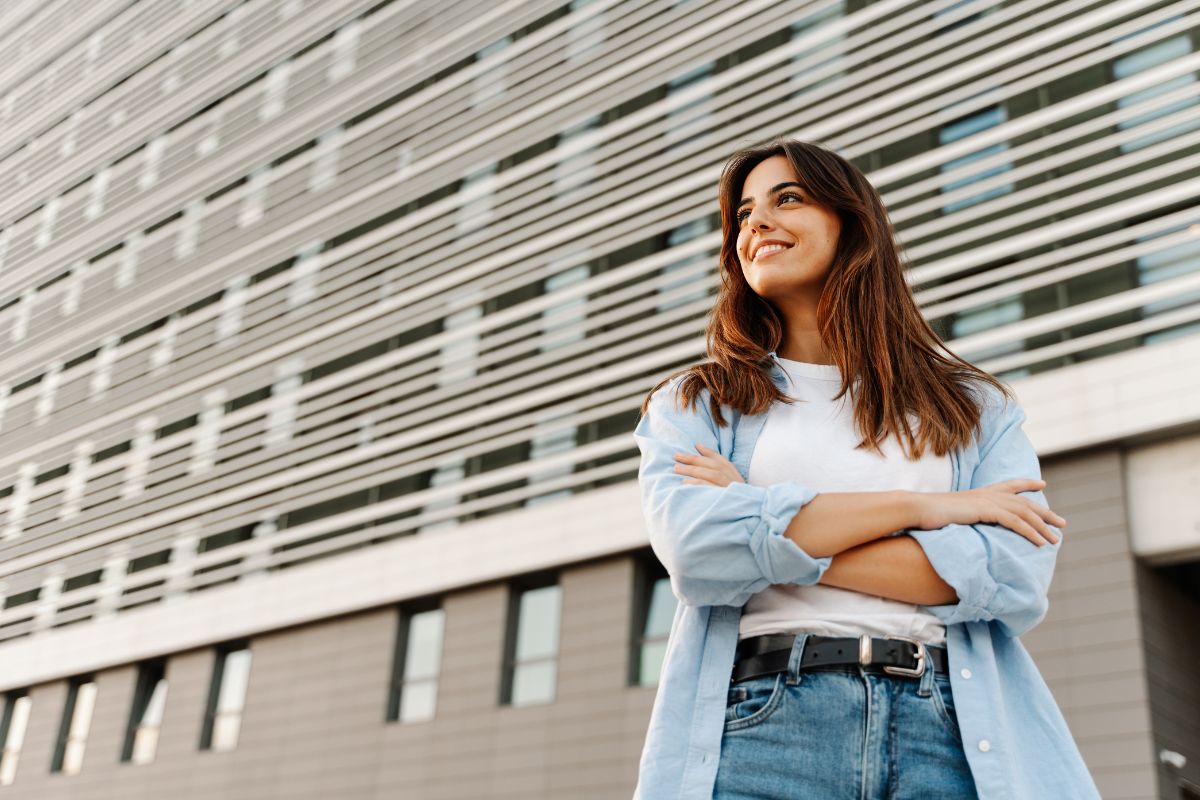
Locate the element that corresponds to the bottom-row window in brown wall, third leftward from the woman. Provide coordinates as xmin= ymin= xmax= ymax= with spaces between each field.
xmin=388 ymin=606 xmax=445 ymax=722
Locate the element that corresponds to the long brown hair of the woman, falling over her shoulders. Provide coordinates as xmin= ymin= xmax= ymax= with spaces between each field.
xmin=641 ymin=139 xmax=1015 ymax=459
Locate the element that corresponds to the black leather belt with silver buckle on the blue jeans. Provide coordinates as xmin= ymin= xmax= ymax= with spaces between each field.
xmin=730 ymin=633 xmax=947 ymax=684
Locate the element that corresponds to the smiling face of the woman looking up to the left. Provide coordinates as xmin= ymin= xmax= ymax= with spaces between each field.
xmin=737 ymin=156 xmax=841 ymax=306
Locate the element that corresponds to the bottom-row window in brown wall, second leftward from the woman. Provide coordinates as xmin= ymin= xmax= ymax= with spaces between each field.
xmin=500 ymin=575 xmax=562 ymax=705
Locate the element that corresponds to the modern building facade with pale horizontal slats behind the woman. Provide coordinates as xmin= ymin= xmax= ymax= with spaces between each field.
xmin=0 ymin=0 xmax=1200 ymax=800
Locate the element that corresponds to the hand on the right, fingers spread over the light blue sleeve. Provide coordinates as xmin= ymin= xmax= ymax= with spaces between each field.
xmin=916 ymin=477 xmax=1067 ymax=547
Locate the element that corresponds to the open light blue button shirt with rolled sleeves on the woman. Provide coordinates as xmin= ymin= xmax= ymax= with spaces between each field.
xmin=634 ymin=353 xmax=1100 ymax=800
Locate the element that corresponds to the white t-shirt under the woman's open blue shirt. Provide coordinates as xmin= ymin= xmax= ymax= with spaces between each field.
xmin=738 ymin=359 xmax=952 ymax=644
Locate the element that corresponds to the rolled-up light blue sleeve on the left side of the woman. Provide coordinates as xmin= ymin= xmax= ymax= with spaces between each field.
xmin=634 ymin=380 xmax=833 ymax=606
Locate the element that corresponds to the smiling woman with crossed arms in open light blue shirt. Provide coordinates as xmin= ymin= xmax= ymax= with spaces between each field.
xmin=634 ymin=140 xmax=1099 ymax=800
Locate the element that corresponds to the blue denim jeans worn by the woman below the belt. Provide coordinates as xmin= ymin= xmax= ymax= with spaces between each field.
xmin=713 ymin=633 xmax=978 ymax=800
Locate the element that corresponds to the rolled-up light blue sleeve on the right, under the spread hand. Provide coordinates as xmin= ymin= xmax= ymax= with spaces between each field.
xmin=907 ymin=402 xmax=1063 ymax=637
